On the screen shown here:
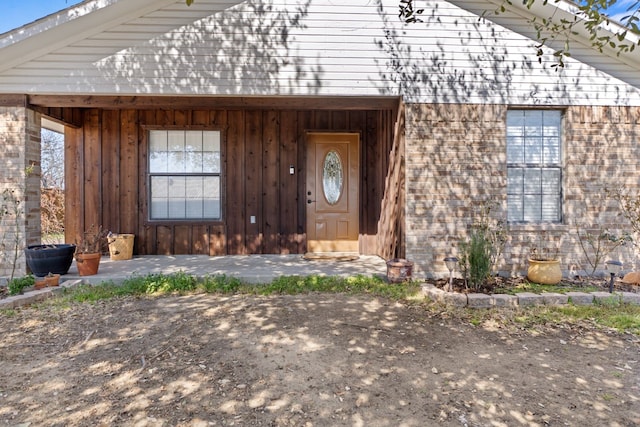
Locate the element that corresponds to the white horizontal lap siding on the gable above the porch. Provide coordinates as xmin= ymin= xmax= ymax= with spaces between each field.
xmin=0 ymin=0 xmax=640 ymax=105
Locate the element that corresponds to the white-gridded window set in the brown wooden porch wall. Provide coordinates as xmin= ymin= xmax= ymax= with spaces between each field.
xmin=149 ymin=130 xmax=221 ymax=220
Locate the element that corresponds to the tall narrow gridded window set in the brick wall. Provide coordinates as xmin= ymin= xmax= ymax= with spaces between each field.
xmin=507 ymin=110 xmax=562 ymax=223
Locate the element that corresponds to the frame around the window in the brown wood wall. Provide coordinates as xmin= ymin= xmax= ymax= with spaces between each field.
xmin=143 ymin=126 xmax=226 ymax=226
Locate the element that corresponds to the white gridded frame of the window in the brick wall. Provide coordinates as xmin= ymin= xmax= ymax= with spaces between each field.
xmin=505 ymin=107 xmax=566 ymax=225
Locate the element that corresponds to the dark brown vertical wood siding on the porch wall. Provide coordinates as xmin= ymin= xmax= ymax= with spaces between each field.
xmin=62 ymin=108 xmax=400 ymax=256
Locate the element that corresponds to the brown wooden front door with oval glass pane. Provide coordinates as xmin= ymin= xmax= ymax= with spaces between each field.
xmin=306 ymin=132 xmax=360 ymax=253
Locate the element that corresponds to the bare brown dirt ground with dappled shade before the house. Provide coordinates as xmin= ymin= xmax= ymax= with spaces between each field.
xmin=0 ymin=294 xmax=640 ymax=427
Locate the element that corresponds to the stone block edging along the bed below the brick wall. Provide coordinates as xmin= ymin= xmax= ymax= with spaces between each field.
xmin=421 ymin=283 xmax=640 ymax=308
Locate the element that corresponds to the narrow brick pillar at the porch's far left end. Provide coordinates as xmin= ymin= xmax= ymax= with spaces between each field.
xmin=0 ymin=107 xmax=40 ymax=278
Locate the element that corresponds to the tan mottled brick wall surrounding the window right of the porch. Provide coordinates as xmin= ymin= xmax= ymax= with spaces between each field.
xmin=406 ymin=104 xmax=640 ymax=277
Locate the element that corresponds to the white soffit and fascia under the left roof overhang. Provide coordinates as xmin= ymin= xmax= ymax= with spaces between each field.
xmin=0 ymin=0 xmax=241 ymax=72
